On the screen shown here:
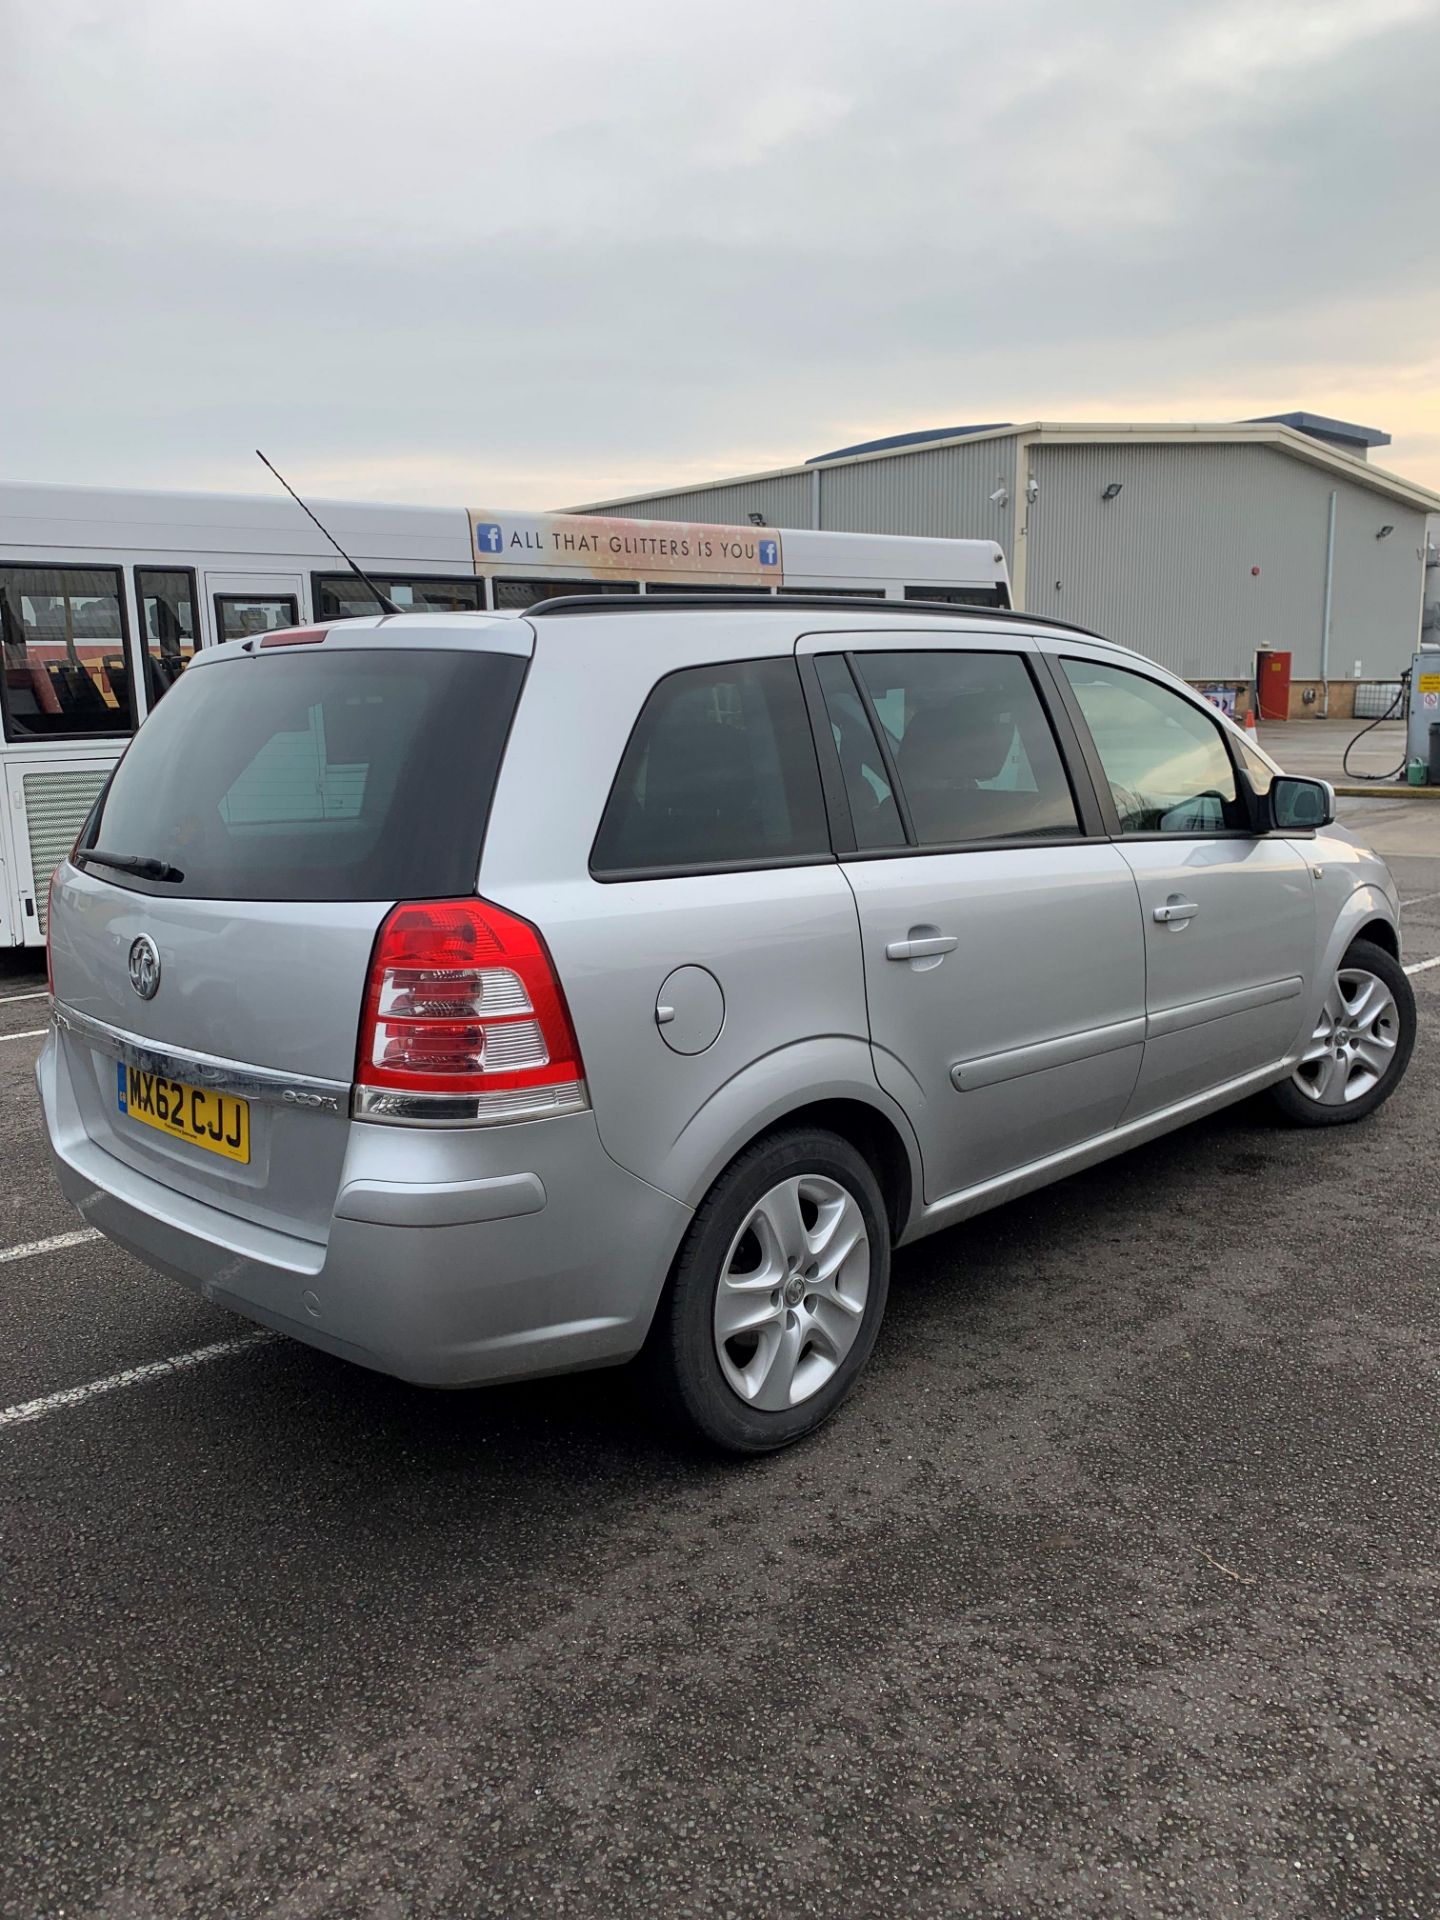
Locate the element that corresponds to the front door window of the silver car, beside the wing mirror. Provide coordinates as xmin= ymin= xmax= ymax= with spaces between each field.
xmin=1062 ymin=660 xmax=1246 ymax=833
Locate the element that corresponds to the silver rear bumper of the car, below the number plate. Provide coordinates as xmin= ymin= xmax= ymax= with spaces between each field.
xmin=36 ymin=1035 xmax=689 ymax=1386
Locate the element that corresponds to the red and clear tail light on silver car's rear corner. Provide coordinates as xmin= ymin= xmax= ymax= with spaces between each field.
xmin=355 ymin=900 xmax=589 ymax=1123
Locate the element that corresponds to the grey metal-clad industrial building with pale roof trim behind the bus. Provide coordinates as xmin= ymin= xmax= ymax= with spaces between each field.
xmin=580 ymin=415 xmax=1440 ymax=684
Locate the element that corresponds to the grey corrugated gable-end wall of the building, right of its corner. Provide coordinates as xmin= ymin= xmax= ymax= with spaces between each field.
xmin=1025 ymin=444 xmax=1425 ymax=680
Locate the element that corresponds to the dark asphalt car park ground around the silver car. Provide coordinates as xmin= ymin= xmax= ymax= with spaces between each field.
xmin=0 ymin=801 xmax=1440 ymax=1920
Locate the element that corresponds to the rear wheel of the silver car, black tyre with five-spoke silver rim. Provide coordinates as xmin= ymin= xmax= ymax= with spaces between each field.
xmin=649 ymin=1127 xmax=891 ymax=1453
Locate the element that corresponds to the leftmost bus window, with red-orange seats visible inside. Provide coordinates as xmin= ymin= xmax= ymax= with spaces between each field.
xmin=0 ymin=566 xmax=134 ymax=741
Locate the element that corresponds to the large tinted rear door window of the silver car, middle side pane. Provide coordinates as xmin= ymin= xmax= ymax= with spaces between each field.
xmin=854 ymin=651 xmax=1079 ymax=847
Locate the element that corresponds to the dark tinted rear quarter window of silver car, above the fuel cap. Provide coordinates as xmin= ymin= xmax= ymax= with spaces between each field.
xmin=589 ymin=659 xmax=831 ymax=876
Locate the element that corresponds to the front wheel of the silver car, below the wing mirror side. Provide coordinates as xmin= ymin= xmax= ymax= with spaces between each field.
xmin=1271 ymin=941 xmax=1415 ymax=1127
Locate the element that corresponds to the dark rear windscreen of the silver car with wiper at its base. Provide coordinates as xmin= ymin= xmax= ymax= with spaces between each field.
xmin=84 ymin=647 xmax=526 ymax=900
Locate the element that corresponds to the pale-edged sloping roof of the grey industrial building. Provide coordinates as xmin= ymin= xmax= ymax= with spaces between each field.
xmin=570 ymin=415 xmax=1440 ymax=513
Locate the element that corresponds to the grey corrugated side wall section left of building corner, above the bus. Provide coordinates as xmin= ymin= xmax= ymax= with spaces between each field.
xmin=820 ymin=434 xmax=1016 ymax=559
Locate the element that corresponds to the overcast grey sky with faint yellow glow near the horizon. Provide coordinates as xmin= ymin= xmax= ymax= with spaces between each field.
xmin=0 ymin=0 xmax=1440 ymax=507
